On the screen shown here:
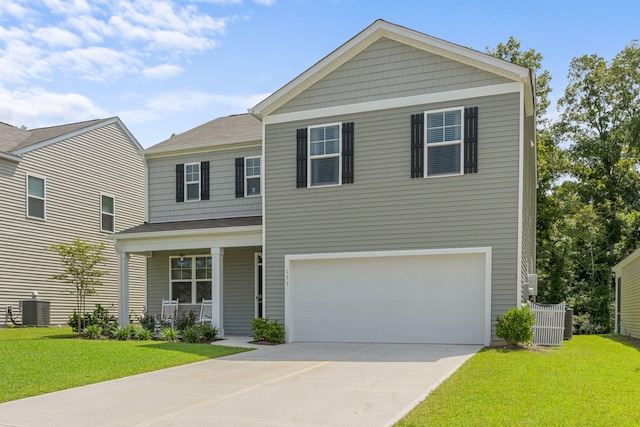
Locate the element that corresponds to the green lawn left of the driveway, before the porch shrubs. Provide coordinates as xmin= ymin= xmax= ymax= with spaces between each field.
xmin=0 ymin=328 xmax=248 ymax=402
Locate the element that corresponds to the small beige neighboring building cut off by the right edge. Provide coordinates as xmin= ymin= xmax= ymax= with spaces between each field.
xmin=613 ymin=249 xmax=640 ymax=338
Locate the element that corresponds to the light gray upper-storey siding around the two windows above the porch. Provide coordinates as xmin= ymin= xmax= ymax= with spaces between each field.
xmin=147 ymin=146 xmax=262 ymax=223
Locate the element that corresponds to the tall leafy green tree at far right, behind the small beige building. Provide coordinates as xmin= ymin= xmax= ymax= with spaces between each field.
xmin=557 ymin=42 xmax=640 ymax=332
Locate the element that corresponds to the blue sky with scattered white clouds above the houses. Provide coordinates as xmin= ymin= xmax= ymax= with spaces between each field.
xmin=0 ymin=0 xmax=640 ymax=148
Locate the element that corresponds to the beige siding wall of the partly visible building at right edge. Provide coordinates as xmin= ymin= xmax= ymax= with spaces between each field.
xmin=620 ymin=258 xmax=640 ymax=338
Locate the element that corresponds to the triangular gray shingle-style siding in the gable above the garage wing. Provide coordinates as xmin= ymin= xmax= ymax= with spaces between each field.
xmin=276 ymin=38 xmax=512 ymax=114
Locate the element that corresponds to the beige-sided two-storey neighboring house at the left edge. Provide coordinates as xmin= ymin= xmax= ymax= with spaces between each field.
xmin=0 ymin=117 xmax=145 ymax=325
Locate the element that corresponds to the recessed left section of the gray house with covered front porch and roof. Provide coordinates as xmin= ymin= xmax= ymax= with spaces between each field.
xmin=114 ymin=114 xmax=263 ymax=335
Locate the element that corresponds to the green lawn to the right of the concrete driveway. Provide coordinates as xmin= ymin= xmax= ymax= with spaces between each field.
xmin=396 ymin=335 xmax=640 ymax=427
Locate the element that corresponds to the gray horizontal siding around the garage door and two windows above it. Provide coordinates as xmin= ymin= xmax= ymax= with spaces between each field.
xmin=264 ymin=93 xmax=520 ymax=342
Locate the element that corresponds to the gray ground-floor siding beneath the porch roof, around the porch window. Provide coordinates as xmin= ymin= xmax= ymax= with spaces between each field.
xmin=147 ymin=247 xmax=261 ymax=335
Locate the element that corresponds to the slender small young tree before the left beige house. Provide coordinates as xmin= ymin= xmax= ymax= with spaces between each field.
xmin=47 ymin=239 xmax=107 ymax=333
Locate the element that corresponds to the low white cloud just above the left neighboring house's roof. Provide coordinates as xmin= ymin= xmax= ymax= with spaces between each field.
xmin=0 ymin=88 xmax=107 ymax=129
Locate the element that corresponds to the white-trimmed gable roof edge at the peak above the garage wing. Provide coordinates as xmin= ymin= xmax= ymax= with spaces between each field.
xmin=249 ymin=19 xmax=535 ymax=119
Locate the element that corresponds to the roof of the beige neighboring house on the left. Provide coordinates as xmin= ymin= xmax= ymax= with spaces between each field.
xmin=0 ymin=117 xmax=142 ymax=162
